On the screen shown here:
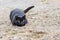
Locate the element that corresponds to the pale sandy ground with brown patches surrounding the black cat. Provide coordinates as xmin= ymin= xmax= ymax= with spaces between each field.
xmin=0 ymin=0 xmax=60 ymax=40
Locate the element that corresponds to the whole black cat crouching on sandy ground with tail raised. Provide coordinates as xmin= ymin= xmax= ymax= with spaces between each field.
xmin=10 ymin=6 xmax=34 ymax=26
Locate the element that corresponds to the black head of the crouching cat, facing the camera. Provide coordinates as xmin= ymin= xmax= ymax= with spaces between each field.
xmin=15 ymin=15 xmax=27 ymax=26
